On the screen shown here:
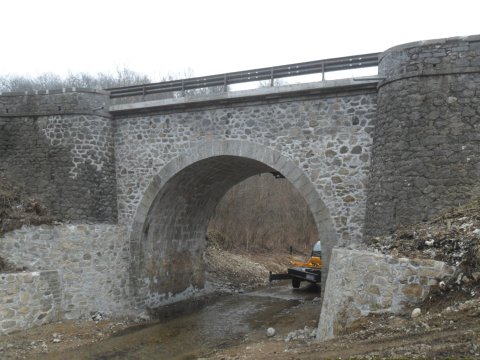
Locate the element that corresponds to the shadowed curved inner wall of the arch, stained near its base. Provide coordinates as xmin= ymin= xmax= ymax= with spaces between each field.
xmin=140 ymin=156 xmax=275 ymax=301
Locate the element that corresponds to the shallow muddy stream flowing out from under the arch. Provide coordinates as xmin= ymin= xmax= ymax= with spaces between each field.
xmin=43 ymin=282 xmax=320 ymax=360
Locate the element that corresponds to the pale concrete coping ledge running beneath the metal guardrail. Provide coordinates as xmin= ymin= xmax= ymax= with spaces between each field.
xmin=109 ymin=78 xmax=378 ymax=114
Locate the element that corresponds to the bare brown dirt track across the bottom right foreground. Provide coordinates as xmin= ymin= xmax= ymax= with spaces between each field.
xmin=209 ymin=298 xmax=480 ymax=359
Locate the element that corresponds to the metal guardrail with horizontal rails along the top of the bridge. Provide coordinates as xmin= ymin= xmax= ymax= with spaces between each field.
xmin=105 ymin=53 xmax=381 ymax=98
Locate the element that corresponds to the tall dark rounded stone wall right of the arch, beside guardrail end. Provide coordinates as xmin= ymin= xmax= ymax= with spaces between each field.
xmin=364 ymin=36 xmax=480 ymax=241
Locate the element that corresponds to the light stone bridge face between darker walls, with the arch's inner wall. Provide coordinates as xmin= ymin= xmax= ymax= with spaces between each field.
xmin=115 ymin=86 xmax=375 ymax=306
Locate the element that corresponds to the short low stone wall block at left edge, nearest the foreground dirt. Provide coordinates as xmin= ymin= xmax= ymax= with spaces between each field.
xmin=0 ymin=270 xmax=63 ymax=334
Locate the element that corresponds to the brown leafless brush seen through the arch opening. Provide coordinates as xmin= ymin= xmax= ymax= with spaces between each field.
xmin=208 ymin=174 xmax=319 ymax=253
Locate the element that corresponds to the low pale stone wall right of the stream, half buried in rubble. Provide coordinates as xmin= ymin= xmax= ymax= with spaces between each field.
xmin=317 ymin=248 xmax=456 ymax=341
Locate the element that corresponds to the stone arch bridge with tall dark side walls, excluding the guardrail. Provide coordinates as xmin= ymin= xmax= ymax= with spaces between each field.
xmin=0 ymin=36 xmax=480 ymax=317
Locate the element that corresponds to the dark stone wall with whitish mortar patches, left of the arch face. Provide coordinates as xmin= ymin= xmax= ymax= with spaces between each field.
xmin=0 ymin=92 xmax=117 ymax=223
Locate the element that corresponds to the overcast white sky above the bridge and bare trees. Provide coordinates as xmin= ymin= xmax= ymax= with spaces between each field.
xmin=0 ymin=0 xmax=480 ymax=83
